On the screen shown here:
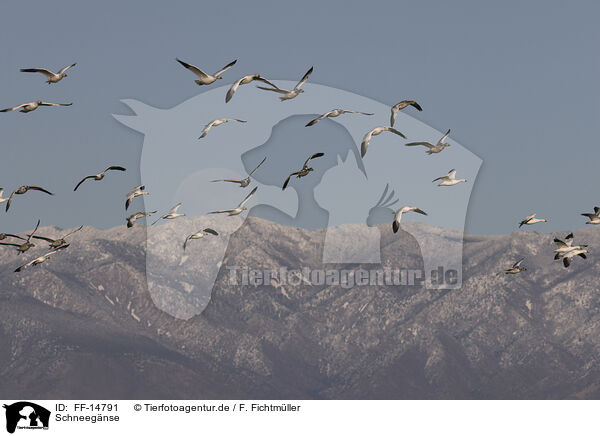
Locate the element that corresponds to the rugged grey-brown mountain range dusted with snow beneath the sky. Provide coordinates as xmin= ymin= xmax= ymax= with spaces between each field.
xmin=0 ymin=217 xmax=600 ymax=399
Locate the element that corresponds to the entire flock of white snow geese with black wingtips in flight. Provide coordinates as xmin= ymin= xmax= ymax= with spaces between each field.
xmin=0 ymin=59 xmax=600 ymax=274
